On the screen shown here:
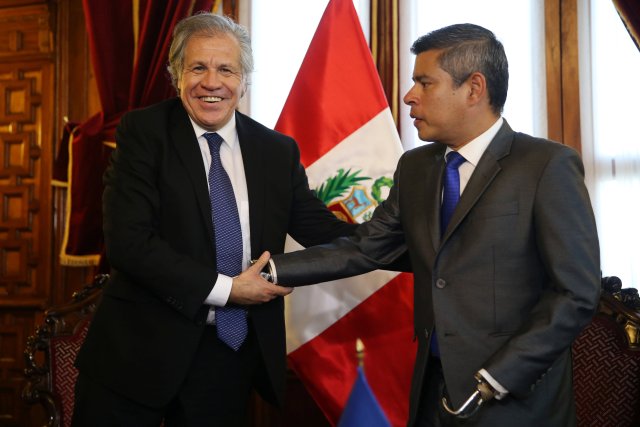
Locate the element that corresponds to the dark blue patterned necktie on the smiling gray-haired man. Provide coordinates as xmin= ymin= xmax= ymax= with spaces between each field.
xmin=204 ymin=132 xmax=248 ymax=351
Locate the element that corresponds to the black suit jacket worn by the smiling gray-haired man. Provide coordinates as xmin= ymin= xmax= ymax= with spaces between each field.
xmin=76 ymin=98 xmax=355 ymax=407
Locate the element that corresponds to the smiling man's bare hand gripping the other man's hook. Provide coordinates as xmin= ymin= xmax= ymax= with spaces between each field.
xmin=229 ymin=251 xmax=293 ymax=305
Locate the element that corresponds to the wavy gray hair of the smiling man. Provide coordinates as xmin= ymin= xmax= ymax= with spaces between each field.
xmin=167 ymin=12 xmax=253 ymax=93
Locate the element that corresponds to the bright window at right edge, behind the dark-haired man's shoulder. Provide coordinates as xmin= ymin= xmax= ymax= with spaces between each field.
xmin=578 ymin=0 xmax=640 ymax=287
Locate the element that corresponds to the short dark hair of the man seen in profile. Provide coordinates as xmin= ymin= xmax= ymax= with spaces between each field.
xmin=411 ymin=24 xmax=509 ymax=114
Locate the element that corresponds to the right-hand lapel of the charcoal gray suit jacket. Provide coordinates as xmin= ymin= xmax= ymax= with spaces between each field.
xmin=442 ymin=120 xmax=513 ymax=243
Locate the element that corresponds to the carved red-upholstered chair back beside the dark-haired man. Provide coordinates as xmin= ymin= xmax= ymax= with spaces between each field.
xmin=572 ymin=277 xmax=640 ymax=427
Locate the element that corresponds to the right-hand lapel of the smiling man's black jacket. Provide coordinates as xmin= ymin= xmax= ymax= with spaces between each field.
xmin=236 ymin=113 xmax=268 ymax=256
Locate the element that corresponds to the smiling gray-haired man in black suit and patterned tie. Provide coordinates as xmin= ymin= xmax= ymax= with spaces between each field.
xmin=73 ymin=14 xmax=355 ymax=427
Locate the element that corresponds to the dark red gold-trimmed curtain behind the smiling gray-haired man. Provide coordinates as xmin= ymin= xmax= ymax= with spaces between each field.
xmin=54 ymin=0 xmax=214 ymax=265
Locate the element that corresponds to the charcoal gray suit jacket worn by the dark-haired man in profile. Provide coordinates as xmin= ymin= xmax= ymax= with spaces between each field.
xmin=274 ymin=122 xmax=600 ymax=427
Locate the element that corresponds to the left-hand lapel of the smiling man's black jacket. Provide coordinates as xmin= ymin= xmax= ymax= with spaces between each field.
xmin=169 ymin=102 xmax=214 ymax=243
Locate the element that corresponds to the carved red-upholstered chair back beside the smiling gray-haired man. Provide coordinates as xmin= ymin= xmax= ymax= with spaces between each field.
xmin=22 ymin=274 xmax=109 ymax=427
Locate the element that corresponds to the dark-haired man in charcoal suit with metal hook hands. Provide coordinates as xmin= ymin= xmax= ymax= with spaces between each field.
xmin=253 ymin=24 xmax=600 ymax=427
